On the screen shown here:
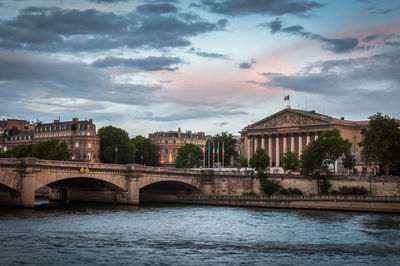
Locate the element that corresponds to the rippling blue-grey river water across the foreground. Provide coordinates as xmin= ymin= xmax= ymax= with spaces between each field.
xmin=0 ymin=204 xmax=400 ymax=266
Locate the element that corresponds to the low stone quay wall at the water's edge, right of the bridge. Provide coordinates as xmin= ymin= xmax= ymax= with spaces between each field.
xmin=177 ymin=195 xmax=400 ymax=213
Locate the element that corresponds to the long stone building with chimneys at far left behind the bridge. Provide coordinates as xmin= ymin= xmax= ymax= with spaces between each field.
xmin=0 ymin=118 xmax=100 ymax=162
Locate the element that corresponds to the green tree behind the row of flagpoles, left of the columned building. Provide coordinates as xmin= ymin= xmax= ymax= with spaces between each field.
xmin=205 ymin=132 xmax=238 ymax=167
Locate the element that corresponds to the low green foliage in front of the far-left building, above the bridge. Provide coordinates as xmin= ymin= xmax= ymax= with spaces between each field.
xmin=0 ymin=139 xmax=69 ymax=161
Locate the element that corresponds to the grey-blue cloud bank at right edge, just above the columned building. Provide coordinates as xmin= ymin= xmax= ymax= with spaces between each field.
xmin=263 ymin=50 xmax=400 ymax=94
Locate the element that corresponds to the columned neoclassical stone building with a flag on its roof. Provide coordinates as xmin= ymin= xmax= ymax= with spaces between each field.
xmin=240 ymin=108 xmax=368 ymax=173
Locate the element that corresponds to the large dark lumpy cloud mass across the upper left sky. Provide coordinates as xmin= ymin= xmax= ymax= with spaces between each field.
xmin=0 ymin=4 xmax=227 ymax=52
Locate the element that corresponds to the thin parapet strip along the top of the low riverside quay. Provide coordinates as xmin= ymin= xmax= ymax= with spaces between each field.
xmin=179 ymin=195 xmax=400 ymax=202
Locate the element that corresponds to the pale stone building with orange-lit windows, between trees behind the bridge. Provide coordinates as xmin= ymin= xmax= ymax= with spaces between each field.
xmin=149 ymin=128 xmax=210 ymax=165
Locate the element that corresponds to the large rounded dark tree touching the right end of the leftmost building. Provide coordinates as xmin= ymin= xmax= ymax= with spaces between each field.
xmin=97 ymin=126 xmax=135 ymax=164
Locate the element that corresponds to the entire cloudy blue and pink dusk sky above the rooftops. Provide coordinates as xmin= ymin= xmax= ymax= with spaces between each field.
xmin=0 ymin=0 xmax=400 ymax=136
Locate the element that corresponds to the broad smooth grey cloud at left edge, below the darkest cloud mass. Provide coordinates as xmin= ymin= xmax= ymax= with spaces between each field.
xmin=0 ymin=52 xmax=160 ymax=105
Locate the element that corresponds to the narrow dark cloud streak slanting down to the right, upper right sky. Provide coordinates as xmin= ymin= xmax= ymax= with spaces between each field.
xmin=259 ymin=20 xmax=359 ymax=54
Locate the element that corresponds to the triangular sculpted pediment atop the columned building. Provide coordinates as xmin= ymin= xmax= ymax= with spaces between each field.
xmin=246 ymin=109 xmax=332 ymax=129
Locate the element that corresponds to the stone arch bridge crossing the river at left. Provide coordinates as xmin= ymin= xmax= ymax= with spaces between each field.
xmin=0 ymin=158 xmax=258 ymax=207
